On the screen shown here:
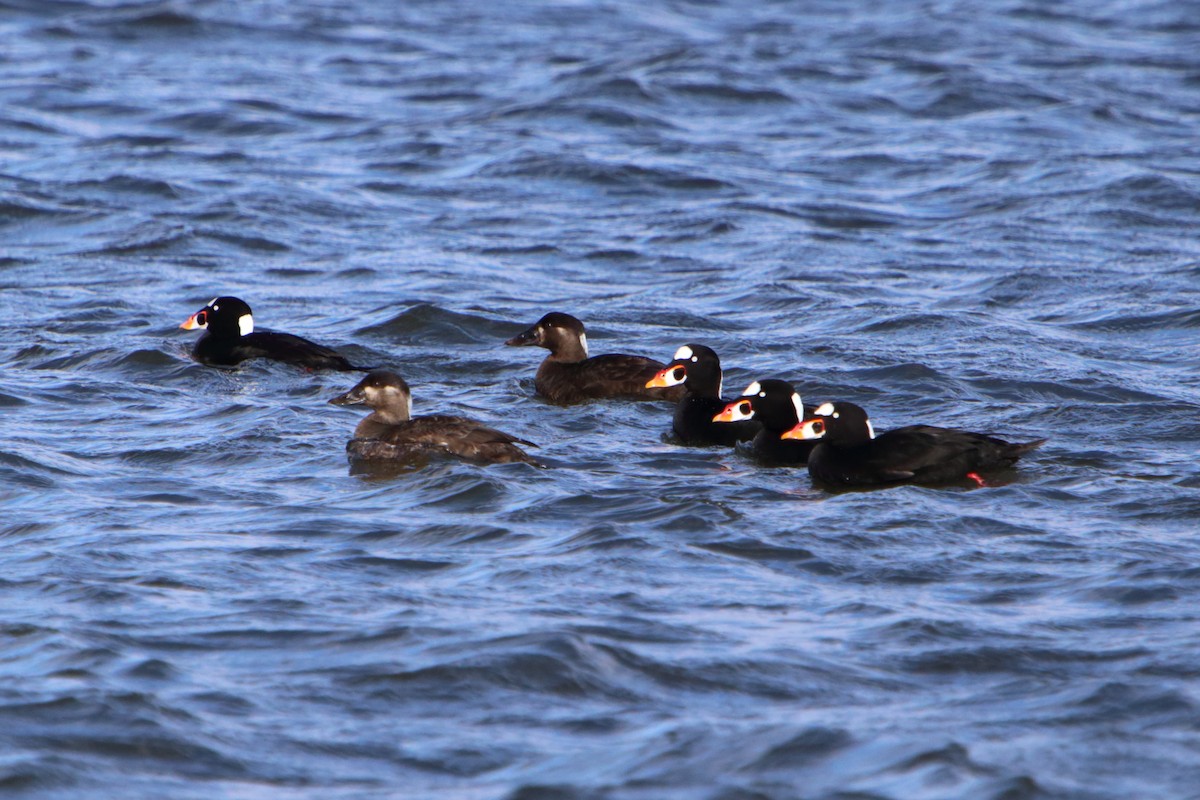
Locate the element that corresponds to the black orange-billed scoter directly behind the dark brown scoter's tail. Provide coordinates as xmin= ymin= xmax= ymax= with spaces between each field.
xmin=646 ymin=344 xmax=762 ymax=445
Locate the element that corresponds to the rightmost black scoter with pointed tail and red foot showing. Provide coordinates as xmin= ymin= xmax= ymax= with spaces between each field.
xmin=784 ymin=403 xmax=1045 ymax=487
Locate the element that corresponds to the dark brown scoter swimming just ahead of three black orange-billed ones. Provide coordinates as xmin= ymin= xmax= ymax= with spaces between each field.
xmin=505 ymin=312 xmax=684 ymax=405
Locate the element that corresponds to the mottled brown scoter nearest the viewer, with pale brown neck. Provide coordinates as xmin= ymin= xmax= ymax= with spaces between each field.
xmin=329 ymin=369 xmax=540 ymax=467
